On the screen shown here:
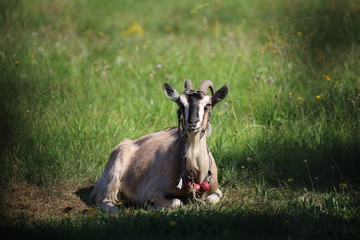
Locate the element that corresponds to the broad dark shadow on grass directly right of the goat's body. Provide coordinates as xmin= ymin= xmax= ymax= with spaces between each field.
xmin=215 ymin=129 xmax=360 ymax=191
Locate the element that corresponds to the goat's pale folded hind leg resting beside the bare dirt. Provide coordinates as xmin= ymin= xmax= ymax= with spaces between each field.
xmin=90 ymin=144 xmax=129 ymax=212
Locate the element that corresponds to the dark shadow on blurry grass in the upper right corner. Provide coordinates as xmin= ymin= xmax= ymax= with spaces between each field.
xmin=278 ymin=0 xmax=360 ymax=77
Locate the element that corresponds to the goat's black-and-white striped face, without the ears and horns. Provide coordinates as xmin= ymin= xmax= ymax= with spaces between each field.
xmin=179 ymin=90 xmax=211 ymax=132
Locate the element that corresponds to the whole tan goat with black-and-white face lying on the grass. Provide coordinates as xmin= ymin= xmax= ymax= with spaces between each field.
xmin=90 ymin=80 xmax=228 ymax=212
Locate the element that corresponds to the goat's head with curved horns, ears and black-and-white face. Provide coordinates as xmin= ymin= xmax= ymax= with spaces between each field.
xmin=163 ymin=80 xmax=228 ymax=133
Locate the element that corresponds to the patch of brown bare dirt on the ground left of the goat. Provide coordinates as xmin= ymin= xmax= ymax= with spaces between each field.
xmin=0 ymin=182 xmax=92 ymax=225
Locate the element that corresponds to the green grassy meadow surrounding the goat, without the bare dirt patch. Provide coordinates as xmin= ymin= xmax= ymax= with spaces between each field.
xmin=0 ymin=0 xmax=360 ymax=239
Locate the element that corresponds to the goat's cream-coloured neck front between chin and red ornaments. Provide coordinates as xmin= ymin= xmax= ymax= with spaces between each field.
xmin=184 ymin=131 xmax=209 ymax=183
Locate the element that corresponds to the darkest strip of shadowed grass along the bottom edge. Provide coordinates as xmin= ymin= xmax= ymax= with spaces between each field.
xmin=3 ymin=209 xmax=359 ymax=239
